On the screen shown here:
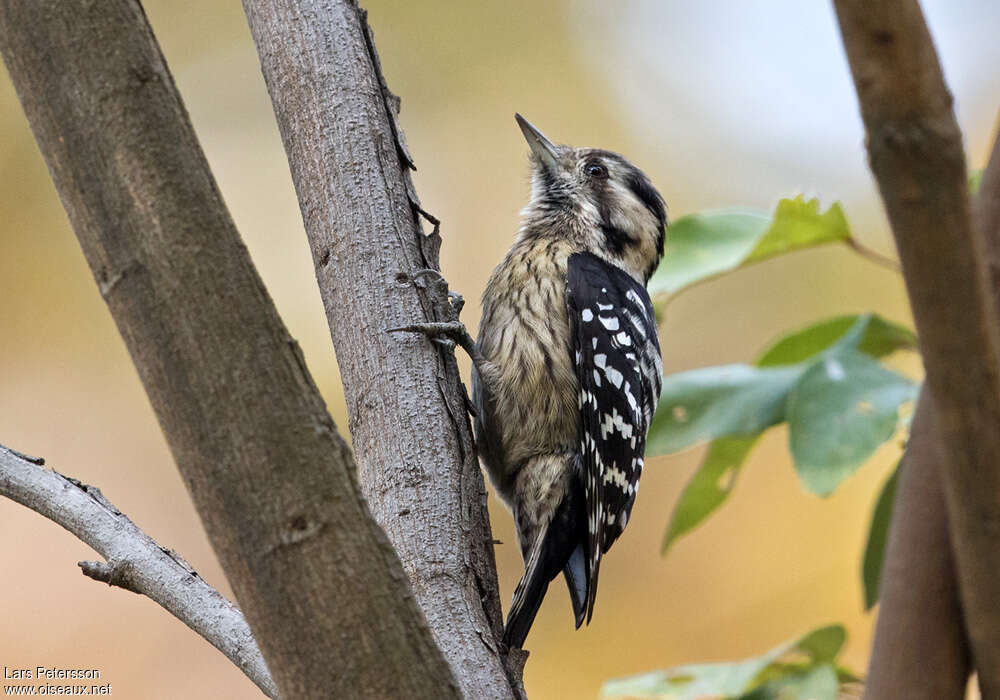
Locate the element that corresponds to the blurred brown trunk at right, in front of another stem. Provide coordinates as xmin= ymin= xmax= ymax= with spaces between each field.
xmin=834 ymin=0 xmax=1000 ymax=698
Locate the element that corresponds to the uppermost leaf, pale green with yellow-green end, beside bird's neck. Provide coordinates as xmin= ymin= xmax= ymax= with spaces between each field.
xmin=648 ymin=195 xmax=850 ymax=297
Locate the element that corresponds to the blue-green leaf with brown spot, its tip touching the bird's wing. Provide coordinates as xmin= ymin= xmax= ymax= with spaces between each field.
xmin=646 ymin=365 xmax=806 ymax=455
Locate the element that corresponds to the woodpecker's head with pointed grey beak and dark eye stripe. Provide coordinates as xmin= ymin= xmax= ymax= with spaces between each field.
xmin=515 ymin=114 xmax=667 ymax=284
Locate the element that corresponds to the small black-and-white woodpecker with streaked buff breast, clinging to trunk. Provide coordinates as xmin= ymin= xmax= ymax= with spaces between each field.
xmin=394 ymin=114 xmax=667 ymax=647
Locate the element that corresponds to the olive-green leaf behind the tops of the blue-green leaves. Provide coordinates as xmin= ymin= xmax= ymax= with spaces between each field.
xmin=756 ymin=314 xmax=917 ymax=367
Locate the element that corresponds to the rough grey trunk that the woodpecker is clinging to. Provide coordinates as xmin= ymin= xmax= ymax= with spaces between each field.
xmin=243 ymin=0 xmax=523 ymax=698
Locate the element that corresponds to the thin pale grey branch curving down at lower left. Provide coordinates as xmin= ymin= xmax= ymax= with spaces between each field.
xmin=0 ymin=445 xmax=278 ymax=698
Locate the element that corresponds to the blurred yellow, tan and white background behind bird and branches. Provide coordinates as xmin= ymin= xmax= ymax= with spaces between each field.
xmin=0 ymin=0 xmax=1000 ymax=700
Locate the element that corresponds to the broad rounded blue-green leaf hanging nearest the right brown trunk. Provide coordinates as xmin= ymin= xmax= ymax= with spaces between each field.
xmin=786 ymin=350 xmax=917 ymax=496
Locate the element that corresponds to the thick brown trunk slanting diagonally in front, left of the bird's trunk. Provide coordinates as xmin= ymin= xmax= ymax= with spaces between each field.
xmin=0 ymin=0 xmax=458 ymax=698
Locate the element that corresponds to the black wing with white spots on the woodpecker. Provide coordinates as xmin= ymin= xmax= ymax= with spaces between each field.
xmin=567 ymin=253 xmax=663 ymax=622
